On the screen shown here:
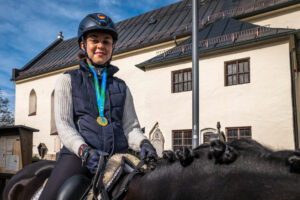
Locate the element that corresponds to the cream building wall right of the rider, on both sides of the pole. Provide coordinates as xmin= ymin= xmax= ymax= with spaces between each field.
xmin=116 ymin=41 xmax=294 ymax=149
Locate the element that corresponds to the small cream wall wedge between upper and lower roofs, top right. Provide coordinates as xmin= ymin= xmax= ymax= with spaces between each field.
xmin=242 ymin=5 xmax=300 ymax=29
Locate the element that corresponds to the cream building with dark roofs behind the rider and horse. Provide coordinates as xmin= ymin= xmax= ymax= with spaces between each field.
xmin=12 ymin=0 xmax=300 ymax=159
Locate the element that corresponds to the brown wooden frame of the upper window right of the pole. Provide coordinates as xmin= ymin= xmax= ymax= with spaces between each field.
xmin=224 ymin=57 xmax=251 ymax=87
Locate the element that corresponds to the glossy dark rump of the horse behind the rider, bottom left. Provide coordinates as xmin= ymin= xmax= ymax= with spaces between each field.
xmin=3 ymin=160 xmax=55 ymax=200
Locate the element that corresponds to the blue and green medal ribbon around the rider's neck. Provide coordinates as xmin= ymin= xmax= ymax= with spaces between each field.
xmin=88 ymin=64 xmax=107 ymax=121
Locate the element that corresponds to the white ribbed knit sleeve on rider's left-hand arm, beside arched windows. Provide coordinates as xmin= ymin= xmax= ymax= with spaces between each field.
xmin=54 ymin=74 xmax=86 ymax=155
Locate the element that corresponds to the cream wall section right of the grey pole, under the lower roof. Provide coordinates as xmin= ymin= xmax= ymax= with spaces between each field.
xmin=200 ymin=42 xmax=294 ymax=149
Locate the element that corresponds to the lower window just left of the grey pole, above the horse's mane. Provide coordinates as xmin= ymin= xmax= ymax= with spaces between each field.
xmin=172 ymin=130 xmax=192 ymax=151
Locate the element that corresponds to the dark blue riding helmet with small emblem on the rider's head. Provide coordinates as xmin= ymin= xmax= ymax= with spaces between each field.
xmin=77 ymin=13 xmax=118 ymax=45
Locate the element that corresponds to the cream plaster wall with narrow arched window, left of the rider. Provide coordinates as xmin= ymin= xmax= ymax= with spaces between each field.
xmin=15 ymin=75 xmax=59 ymax=154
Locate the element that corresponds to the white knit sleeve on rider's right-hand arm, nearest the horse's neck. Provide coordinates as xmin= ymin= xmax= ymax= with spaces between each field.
xmin=123 ymin=87 xmax=147 ymax=151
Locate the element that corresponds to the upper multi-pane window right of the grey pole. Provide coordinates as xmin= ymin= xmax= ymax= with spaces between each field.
xmin=225 ymin=58 xmax=250 ymax=86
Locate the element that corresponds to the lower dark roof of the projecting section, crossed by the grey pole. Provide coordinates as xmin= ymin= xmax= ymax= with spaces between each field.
xmin=136 ymin=17 xmax=295 ymax=69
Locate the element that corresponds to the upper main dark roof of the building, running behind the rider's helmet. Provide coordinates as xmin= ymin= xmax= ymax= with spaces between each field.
xmin=12 ymin=0 xmax=300 ymax=80
